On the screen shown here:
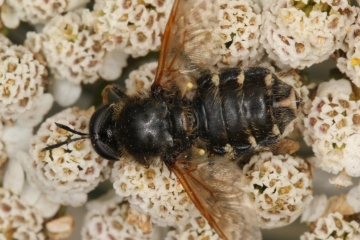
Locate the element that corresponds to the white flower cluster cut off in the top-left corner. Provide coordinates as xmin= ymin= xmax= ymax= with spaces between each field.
xmin=0 ymin=0 xmax=89 ymax=28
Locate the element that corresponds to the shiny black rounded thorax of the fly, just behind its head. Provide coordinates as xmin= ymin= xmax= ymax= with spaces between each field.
xmin=116 ymin=98 xmax=174 ymax=164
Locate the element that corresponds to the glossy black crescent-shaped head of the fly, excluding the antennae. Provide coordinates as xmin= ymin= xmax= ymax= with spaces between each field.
xmin=89 ymin=104 xmax=120 ymax=161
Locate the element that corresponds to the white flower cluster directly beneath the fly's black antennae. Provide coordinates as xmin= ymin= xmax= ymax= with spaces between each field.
xmin=22 ymin=108 xmax=110 ymax=206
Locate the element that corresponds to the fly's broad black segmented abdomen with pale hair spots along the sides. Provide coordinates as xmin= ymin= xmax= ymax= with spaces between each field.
xmin=193 ymin=68 xmax=297 ymax=154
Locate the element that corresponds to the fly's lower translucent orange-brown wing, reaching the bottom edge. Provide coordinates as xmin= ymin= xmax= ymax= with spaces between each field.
xmin=171 ymin=146 xmax=261 ymax=240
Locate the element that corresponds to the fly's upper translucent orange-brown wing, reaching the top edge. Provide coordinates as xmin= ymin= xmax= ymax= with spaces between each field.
xmin=152 ymin=0 xmax=220 ymax=92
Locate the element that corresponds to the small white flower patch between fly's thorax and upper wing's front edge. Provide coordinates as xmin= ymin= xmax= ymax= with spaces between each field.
xmin=125 ymin=61 xmax=158 ymax=96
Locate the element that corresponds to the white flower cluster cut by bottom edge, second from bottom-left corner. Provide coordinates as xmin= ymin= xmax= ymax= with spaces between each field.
xmin=81 ymin=191 xmax=161 ymax=240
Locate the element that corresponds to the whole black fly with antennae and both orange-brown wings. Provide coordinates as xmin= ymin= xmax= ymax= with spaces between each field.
xmin=44 ymin=0 xmax=302 ymax=239
